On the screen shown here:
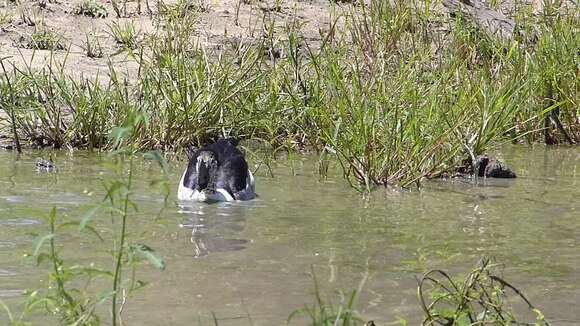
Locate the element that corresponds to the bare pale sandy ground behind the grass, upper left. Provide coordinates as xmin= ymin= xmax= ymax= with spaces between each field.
xmin=0 ymin=0 xmax=342 ymax=79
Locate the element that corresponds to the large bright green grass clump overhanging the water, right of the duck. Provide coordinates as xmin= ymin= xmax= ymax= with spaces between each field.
xmin=294 ymin=1 xmax=518 ymax=190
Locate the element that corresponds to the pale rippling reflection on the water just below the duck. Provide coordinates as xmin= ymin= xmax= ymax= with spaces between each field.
xmin=174 ymin=202 xmax=251 ymax=258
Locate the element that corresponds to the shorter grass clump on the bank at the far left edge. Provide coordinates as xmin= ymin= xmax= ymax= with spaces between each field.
xmin=0 ymin=50 xmax=137 ymax=148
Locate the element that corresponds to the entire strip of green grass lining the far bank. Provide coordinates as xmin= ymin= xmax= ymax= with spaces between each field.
xmin=0 ymin=0 xmax=580 ymax=190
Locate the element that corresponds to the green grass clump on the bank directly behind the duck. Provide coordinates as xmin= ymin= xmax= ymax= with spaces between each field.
xmin=133 ymin=6 xmax=310 ymax=149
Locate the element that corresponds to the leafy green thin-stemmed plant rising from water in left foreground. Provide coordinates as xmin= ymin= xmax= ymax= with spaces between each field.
xmin=17 ymin=111 xmax=167 ymax=325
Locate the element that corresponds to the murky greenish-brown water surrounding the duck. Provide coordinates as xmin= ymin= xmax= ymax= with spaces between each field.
xmin=0 ymin=146 xmax=580 ymax=325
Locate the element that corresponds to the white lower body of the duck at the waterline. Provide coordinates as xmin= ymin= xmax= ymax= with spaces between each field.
xmin=177 ymin=169 xmax=256 ymax=202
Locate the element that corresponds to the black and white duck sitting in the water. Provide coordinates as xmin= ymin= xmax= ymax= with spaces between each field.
xmin=177 ymin=138 xmax=256 ymax=202
